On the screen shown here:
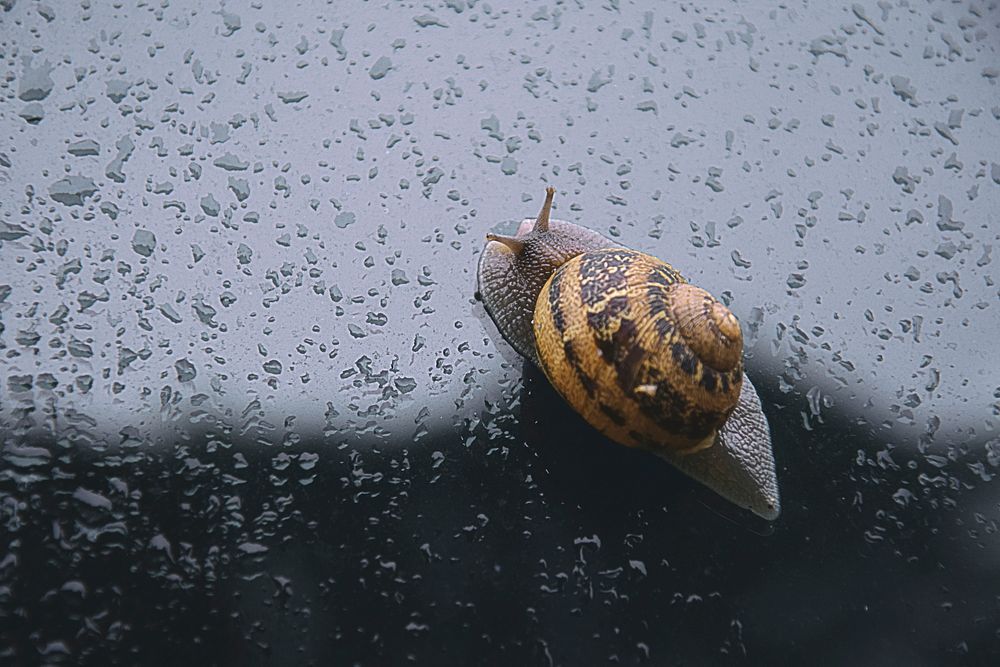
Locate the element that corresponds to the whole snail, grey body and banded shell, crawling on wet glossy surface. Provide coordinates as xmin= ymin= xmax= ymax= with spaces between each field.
xmin=477 ymin=187 xmax=780 ymax=520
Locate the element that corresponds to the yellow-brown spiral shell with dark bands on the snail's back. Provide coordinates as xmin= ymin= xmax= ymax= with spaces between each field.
xmin=533 ymin=248 xmax=743 ymax=453
